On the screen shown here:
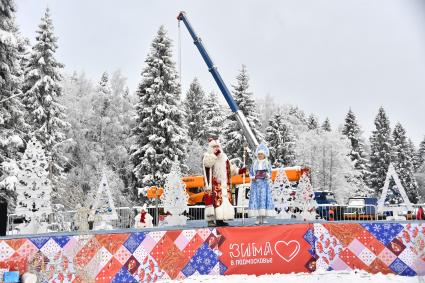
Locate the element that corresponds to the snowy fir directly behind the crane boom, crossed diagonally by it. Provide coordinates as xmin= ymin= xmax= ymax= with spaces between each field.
xmin=223 ymin=65 xmax=263 ymax=159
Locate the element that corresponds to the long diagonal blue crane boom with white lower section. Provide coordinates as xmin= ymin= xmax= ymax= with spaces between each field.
xmin=177 ymin=11 xmax=258 ymax=151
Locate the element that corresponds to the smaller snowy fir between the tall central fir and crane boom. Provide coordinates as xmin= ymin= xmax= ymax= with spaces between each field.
xmin=184 ymin=78 xmax=208 ymax=143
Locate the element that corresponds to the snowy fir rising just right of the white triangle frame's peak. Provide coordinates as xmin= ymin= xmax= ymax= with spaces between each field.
xmin=391 ymin=123 xmax=419 ymax=203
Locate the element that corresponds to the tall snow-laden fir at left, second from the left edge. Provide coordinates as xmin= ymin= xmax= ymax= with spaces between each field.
xmin=23 ymin=9 xmax=69 ymax=176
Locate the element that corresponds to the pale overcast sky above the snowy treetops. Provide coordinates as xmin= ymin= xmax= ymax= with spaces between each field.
xmin=17 ymin=0 xmax=425 ymax=144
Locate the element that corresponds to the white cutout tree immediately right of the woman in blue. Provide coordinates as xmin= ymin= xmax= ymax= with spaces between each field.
xmin=272 ymin=169 xmax=294 ymax=219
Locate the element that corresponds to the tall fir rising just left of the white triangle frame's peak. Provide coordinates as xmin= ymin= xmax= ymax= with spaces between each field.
xmin=369 ymin=107 xmax=392 ymax=195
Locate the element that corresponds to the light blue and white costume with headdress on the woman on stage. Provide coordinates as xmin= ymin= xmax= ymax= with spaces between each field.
xmin=248 ymin=144 xmax=276 ymax=217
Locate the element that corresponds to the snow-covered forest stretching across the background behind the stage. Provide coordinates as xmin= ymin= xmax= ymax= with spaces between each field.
xmin=0 ymin=0 xmax=425 ymax=216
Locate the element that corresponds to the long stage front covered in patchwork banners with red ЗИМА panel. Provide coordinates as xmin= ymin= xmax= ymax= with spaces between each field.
xmin=0 ymin=222 xmax=425 ymax=282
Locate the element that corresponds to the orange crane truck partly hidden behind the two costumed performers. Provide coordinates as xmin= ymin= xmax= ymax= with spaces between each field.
xmin=147 ymin=166 xmax=310 ymax=205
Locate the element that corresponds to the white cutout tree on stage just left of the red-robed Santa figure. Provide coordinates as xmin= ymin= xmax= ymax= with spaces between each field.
xmin=161 ymin=161 xmax=189 ymax=226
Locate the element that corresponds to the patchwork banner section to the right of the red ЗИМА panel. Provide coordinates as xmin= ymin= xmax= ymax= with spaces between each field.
xmin=314 ymin=222 xmax=425 ymax=276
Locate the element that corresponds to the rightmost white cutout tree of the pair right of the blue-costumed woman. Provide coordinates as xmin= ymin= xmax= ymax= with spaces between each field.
xmin=296 ymin=174 xmax=317 ymax=220
